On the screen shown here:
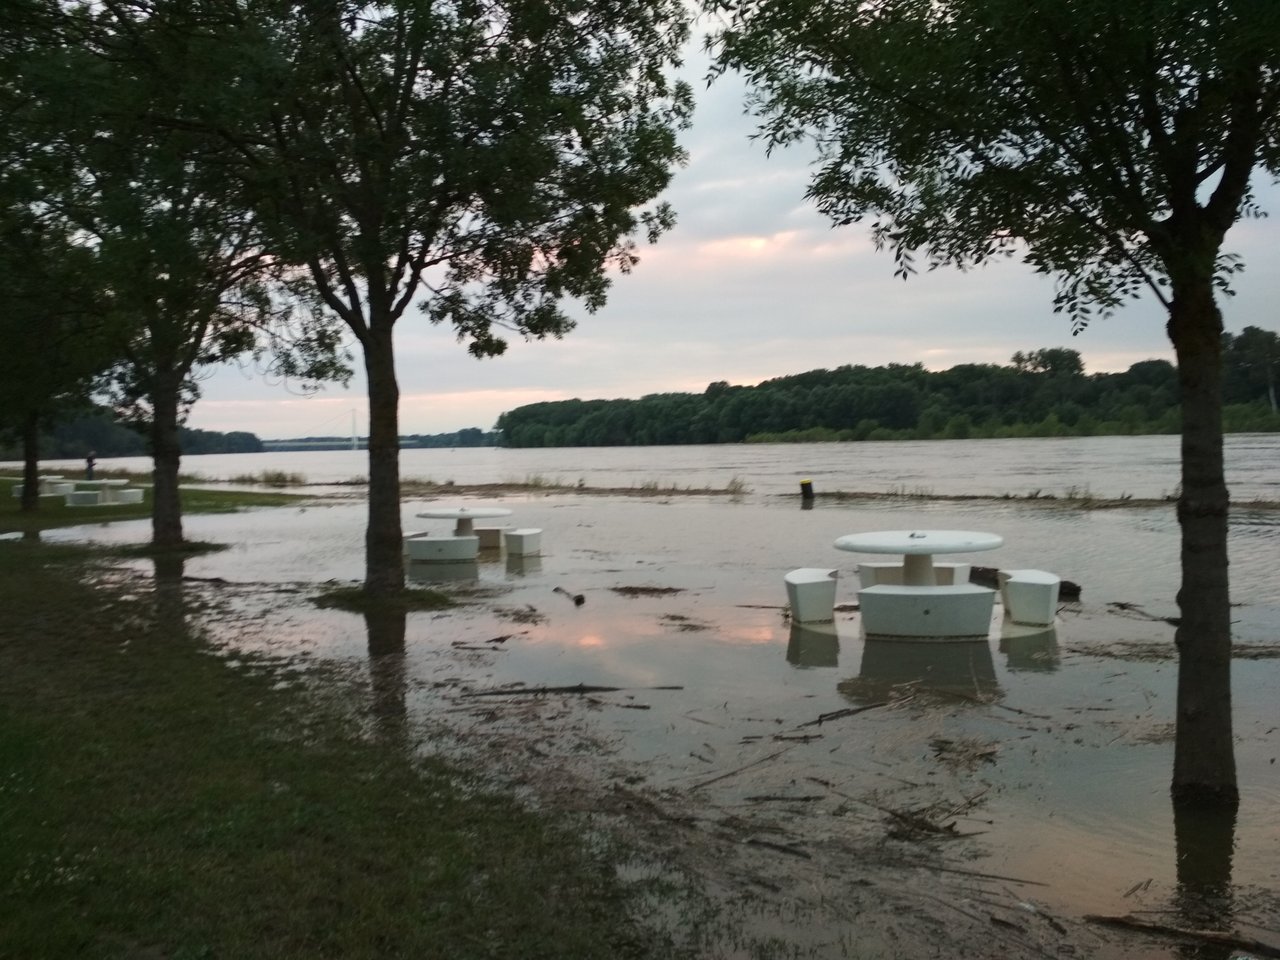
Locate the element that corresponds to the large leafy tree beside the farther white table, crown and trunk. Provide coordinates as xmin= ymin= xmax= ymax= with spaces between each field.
xmin=110 ymin=0 xmax=691 ymax=595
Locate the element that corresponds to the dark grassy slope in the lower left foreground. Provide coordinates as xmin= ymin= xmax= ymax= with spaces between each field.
xmin=0 ymin=541 xmax=686 ymax=960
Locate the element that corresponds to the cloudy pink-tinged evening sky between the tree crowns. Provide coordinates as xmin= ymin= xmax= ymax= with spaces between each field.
xmin=189 ymin=39 xmax=1280 ymax=439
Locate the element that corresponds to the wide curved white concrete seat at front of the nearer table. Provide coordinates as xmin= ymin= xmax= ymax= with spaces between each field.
xmin=858 ymin=582 xmax=996 ymax=639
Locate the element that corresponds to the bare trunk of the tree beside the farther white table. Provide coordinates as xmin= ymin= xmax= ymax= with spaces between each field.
xmin=364 ymin=321 xmax=404 ymax=596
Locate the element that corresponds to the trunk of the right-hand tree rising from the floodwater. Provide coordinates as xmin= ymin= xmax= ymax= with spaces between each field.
xmin=1169 ymin=281 xmax=1239 ymax=805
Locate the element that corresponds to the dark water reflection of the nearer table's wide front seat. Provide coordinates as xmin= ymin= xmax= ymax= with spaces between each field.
xmin=838 ymin=640 xmax=1000 ymax=700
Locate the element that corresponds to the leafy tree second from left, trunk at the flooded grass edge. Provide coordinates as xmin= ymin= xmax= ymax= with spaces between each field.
xmin=36 ymin=5 xmax=344 ymax=549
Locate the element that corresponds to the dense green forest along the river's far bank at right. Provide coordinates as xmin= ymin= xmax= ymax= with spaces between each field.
xmin=498 ymin=328 xmax=1280 ymax=447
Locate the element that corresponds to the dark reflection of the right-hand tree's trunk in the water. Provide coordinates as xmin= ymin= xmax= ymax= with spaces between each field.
xmin=1174 ymin=801 xmax=1236 ymax=960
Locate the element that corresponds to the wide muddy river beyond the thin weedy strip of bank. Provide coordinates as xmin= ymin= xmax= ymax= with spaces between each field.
xmin=17 ymin=434 xmax=1280 ymax=502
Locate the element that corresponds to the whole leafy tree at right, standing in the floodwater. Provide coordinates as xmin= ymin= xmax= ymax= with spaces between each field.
xmin=704 ymin=0 xmax=1280 ymax=804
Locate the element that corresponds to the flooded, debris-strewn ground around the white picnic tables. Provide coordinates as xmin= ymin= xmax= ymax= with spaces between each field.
xmin=52 ymin=497 xmax=1280 ymax=957
